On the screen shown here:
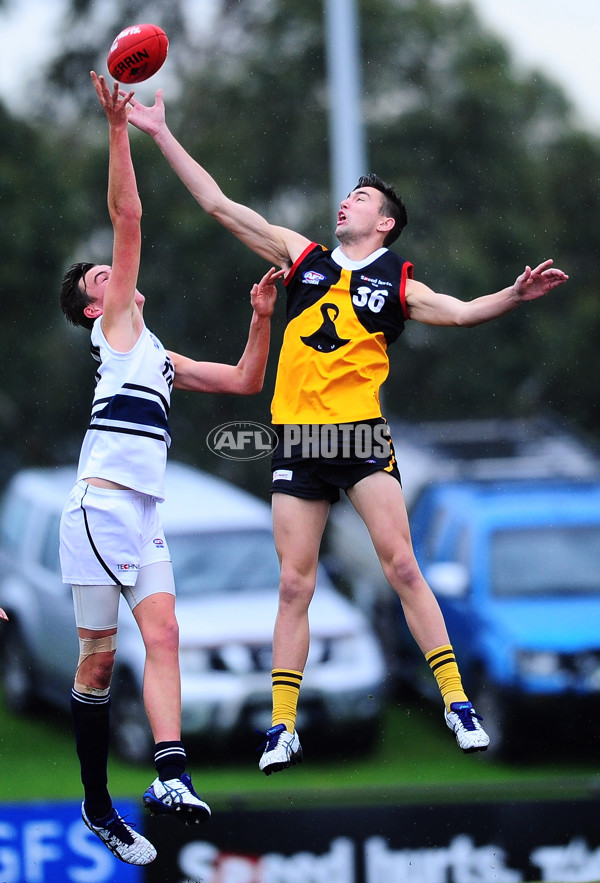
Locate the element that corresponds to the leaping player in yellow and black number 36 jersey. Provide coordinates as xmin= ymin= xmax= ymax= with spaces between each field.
xmin=129 ymin=91 xmax=568 ymax=775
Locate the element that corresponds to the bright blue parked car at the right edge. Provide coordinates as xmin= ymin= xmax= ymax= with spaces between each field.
xmin=400 ymin=479 xmax=600 ymax=754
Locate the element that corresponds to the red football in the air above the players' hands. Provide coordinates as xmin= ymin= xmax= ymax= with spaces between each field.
xmin=106 ymin=25 xmax=169 ymax=83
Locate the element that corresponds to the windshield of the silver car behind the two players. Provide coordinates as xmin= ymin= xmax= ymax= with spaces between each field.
xmin=167 ymin=530 xmax=279 ymax=597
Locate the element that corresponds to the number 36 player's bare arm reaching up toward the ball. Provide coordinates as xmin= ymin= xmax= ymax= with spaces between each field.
xmin=124 ymin=89 xmax=309 ymax=269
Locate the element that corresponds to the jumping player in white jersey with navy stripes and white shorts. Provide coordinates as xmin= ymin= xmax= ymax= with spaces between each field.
xmin=60 ymin=72 xmax=282 ymax=865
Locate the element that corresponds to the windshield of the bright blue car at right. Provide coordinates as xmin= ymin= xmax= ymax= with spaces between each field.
xmin=491 ymin=525 xmax=600 ymax=596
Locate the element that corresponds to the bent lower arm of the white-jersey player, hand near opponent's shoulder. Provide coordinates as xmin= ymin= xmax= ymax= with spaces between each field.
xmin=170 ymin=267 xmax=284 ymax=395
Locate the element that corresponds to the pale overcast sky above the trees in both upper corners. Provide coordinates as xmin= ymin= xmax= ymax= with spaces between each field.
xmin=0 ymin=0 xmax=600 ymax=134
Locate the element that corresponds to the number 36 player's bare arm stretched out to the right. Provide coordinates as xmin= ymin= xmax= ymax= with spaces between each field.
xmin=406 ymin=260 xmax=569 ymax=327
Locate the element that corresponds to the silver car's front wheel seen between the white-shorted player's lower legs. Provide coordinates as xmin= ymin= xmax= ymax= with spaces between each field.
xmin=111 ymin=671 xmax=154 ymax=765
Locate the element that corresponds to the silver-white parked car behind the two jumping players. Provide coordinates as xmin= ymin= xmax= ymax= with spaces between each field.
xmin=0 ymin=463 xmax=385 ymax=762
